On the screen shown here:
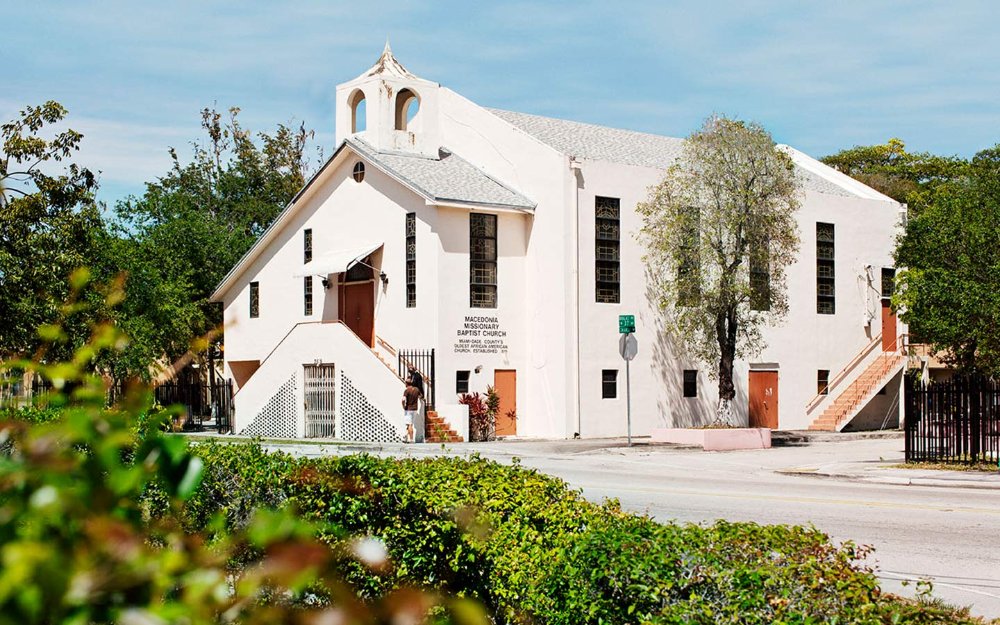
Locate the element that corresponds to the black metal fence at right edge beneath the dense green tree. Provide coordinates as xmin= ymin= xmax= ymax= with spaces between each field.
xmin=905 ymin=375 xmax=1000 ymax=464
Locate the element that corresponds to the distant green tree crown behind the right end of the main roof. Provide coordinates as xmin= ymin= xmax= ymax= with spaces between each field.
xmin=822 ymin=138 xmax=966 ymax=212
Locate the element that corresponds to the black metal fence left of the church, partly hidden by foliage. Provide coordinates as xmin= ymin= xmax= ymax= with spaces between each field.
xmin=31 ymin=379 xmax=235 ymax=434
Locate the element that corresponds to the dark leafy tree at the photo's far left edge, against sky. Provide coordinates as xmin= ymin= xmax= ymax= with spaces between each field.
xmin=0 ymin=101 xmax=103 ymax=358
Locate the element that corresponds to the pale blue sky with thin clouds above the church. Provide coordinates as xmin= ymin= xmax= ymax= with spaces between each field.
xmin=0 ymin=0 xmax=1000 ymax=203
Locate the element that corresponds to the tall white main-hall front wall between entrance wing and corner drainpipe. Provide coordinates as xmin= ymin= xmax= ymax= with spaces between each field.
xmin=439 ymin=88 xmax=577 ymax=438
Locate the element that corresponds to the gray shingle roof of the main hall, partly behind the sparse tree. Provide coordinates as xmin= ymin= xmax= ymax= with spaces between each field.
xmin=488 ymin=109 xmax=856 ymax=197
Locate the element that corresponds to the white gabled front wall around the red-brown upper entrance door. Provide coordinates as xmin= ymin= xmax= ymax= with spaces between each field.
xmin=224 ymin=154 xmax=438 ymax=382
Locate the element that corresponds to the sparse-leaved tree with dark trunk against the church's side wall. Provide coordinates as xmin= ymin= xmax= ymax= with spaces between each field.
xmin=638 ymin=117 xmax=799 ymax=424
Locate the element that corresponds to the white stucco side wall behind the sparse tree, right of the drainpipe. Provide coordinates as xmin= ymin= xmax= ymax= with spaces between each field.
xmin=567 ymin=161 xmax=899 ymax=437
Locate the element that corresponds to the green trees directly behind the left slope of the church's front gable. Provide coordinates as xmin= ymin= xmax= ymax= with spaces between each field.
xmin=108 ymin=108 xmax=312 ymax=374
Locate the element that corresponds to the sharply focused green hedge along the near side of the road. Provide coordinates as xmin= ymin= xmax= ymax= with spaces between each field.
xmin=187 ymin=443 xmax=981 ymax=625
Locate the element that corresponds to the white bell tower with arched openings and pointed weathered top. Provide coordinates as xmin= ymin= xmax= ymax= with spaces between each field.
xmin=336 ymin=41 xmax=441 ymax=158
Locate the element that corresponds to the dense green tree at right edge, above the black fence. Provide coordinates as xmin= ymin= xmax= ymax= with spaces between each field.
xmin=894 ymin=145 xmax=1000 ymax=375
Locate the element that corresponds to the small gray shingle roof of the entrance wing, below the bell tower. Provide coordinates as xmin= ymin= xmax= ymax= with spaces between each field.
xmin=347 ymin=137 xmax=535 ymax=210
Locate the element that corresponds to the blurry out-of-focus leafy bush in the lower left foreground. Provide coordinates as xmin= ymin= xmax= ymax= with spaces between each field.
xmin=0 ymin=326 xmax=483 ymax=625
